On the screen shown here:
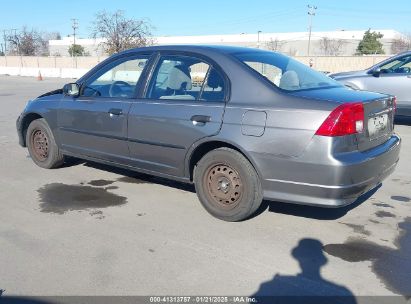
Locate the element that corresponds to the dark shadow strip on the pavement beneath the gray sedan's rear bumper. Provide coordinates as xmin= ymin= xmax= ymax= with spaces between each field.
xmin=252 ymin=184 xmax=382 ymax=220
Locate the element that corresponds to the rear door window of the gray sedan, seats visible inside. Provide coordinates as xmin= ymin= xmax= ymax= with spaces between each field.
xmin=146 ymin=56 xmax=225 ymax=101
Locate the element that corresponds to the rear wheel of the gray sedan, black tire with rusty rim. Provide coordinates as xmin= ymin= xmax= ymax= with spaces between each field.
xmin=194 ymin=147 xmax=263 ymax=222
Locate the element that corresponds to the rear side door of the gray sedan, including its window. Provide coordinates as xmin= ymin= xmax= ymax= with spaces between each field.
xmin=128 ymin=53 xmax=228 ymax=176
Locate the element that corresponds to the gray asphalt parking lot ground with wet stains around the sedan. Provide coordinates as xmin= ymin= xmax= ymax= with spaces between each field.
xmin=0 ymin=76 xmax=411 ymax=296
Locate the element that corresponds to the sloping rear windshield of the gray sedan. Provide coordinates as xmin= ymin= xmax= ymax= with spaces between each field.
xmin=233 ymin=51 xmax=342 ymax=91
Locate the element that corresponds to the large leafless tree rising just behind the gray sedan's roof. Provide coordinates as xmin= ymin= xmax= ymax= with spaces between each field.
xmin=92 ymin=11 xmax=153 ymax=55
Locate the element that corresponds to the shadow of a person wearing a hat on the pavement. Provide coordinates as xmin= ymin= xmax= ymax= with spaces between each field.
xmin=251 ymin=238 xmax=357 ymax=304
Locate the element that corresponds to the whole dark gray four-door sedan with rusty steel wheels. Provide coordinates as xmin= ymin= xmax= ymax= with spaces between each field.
xmin=17 ymin=46 xmax=400 ymax=221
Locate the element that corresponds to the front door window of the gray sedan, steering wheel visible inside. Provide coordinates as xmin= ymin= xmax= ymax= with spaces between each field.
xmin=81 ymin=56 xmax=148 ymax=98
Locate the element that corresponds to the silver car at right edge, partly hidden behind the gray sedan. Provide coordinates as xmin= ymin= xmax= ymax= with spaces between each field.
xmin=329 ymin=51 xmax=411 ymax=117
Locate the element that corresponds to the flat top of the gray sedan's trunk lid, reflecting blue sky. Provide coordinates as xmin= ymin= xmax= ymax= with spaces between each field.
xmin=291 ymin=87 xmax=386 ymax=103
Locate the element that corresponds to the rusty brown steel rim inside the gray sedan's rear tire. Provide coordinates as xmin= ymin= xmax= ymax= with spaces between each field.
xmin=203 ymin=164 xmax=243 ymax=209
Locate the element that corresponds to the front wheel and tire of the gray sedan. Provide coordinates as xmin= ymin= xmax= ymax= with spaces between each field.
xmin=26 ymin=118 xmax=64 ymax=169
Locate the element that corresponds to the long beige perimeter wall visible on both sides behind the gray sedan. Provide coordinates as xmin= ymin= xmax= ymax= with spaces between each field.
xmin=0 ymin=55 xmax=388 ymax=78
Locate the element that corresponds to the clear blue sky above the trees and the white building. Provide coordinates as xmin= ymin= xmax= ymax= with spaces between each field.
xmin=0 ymin=0 xmax=411 ymax=38
